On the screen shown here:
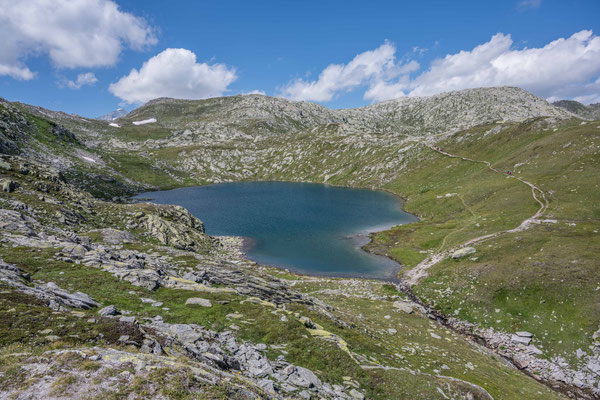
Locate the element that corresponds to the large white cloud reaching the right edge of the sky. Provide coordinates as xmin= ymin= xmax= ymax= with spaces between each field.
xmin=409 ymin=31 xmax=600 ymax=97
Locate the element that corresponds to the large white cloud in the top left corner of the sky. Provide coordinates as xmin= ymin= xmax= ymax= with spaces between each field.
xmin=0 ymin=0 xmax=156 ymax=80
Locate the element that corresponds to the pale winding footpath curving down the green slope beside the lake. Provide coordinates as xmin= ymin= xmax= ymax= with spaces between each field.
xmin=403 ymin=148 xmax=549 ymax=286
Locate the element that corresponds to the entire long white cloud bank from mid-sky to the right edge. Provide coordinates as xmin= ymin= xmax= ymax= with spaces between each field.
xmin=290 ymin=30 xmax=600 ymax=103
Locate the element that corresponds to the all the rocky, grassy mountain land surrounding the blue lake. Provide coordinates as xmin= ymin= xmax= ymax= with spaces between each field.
xmin=0 ymin=88 xmax=600 ymax=399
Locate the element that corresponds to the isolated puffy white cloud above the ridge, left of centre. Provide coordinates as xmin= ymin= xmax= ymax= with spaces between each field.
xmin=109 ymin=49 xmax=237 ymax=103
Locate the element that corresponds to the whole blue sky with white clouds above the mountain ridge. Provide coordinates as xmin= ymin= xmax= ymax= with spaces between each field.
xmin=0 ymin=0 xmax=600 ymax=117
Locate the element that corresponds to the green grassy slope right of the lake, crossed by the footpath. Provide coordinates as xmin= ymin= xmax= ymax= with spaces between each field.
xmin=370 ymin=121 xmax=600 ymax=364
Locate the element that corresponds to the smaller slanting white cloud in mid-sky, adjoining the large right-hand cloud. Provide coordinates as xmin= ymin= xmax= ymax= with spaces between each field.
xmin=281 ymin=42 xmax=419 ymax=101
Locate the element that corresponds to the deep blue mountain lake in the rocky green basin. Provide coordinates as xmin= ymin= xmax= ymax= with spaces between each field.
xmin=137 ymin=182 xmax=416 ymax=278
